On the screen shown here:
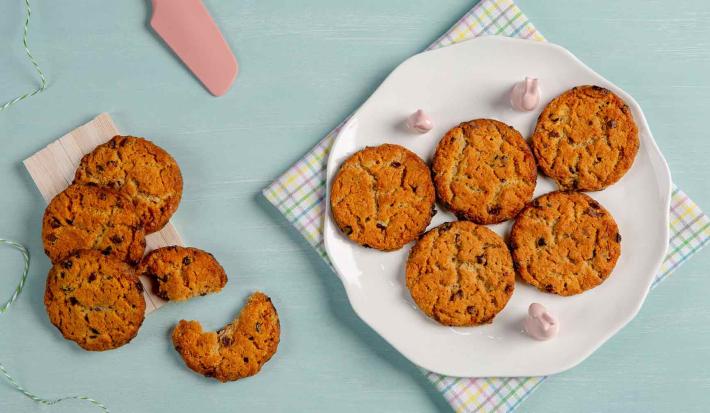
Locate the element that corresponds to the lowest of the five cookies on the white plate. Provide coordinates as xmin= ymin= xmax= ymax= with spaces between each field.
xmin=406 ymin=221 xmax=515 ymax=326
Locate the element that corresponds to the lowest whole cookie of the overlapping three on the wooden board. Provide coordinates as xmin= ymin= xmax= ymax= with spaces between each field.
xmin=44 ymin=250 xmax=145 ymax=351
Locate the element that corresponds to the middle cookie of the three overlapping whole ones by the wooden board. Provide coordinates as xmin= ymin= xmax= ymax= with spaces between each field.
xmin=42 ymin=184 xmax=145 ymax=265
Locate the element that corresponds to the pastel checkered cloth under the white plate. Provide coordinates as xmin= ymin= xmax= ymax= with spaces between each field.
xmin=264 ymin=0 xmax=710 ymax=412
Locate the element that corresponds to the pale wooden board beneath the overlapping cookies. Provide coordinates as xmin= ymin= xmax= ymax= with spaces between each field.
xmin=23 ymin=113 xmax=183 ymax=314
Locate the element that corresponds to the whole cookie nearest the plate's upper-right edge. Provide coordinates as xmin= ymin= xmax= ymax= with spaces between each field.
xmin=531 ymin=86 xmax=639 ymax=191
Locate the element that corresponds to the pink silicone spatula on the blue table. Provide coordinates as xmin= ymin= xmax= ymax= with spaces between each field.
xmin=150 ymin=0 xmax=239 ymax=96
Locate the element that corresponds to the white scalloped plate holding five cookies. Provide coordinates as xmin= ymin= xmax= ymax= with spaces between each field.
xmin=324 ymin=37 xmax=671 ymax=377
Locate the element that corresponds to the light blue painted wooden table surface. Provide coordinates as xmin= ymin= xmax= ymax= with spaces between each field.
xmin=0 ymin=0 xmax=710 ymax=412
